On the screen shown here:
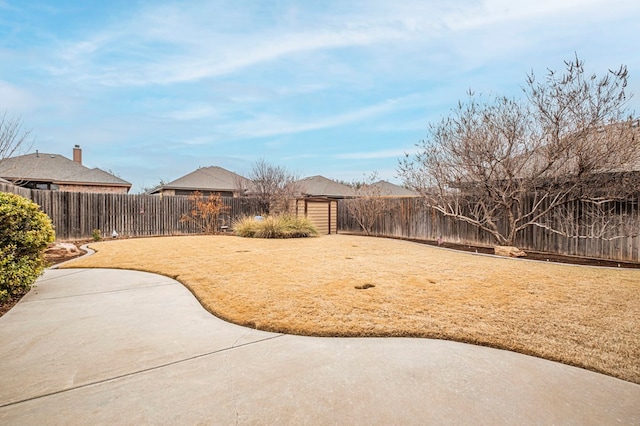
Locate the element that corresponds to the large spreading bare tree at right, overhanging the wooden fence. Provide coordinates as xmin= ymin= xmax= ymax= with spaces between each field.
xmin=398 ymin=58 xmax=640 ymax=245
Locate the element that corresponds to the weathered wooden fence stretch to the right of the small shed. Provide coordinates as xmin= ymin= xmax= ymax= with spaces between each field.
xmin=338 ymin=198 xmax=640 ymax=262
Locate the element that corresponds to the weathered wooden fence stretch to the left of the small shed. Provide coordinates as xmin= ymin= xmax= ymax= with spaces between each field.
xmin=0 ymin=183 xmax=257 ymax=241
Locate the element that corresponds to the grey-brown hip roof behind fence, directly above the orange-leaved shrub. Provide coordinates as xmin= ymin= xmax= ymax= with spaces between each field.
xmin=151 ymin=166 xmax=250 ymax=194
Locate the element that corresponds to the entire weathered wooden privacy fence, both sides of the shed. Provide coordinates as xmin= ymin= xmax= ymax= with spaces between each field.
xmin=0 ymin=183 xmax=640 ymax=262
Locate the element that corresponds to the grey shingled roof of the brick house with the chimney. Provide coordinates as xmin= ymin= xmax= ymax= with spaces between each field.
xmin=0 ymin=152 xmax=131 ymax=188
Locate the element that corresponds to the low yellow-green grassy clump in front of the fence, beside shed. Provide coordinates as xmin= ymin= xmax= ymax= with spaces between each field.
xmin=233 ymin=215 xmax=318 ymax=238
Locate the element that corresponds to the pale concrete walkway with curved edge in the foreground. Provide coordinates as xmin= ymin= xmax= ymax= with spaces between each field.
xmin=0 ymin=269 xmax=640 ymax=425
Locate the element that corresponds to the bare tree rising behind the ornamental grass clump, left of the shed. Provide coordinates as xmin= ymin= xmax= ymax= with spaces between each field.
xmin=247 ymin=160 xmax=300 ymax=214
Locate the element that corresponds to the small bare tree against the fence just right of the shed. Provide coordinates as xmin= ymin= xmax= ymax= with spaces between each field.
xmin=345 ymin=172 xmax=388 ymax=235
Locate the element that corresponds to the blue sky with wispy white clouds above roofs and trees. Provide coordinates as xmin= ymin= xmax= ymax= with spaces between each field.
xmin=0 ymin=0 xmax=640 ymax=192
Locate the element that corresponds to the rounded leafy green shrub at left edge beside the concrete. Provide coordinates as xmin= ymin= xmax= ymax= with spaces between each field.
xmin=0 ymin=192 xmax=55 ymax=303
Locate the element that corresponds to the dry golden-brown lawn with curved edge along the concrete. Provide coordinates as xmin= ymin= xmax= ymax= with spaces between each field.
xmin=67 ymin=235 xmax=640 ymax=383
